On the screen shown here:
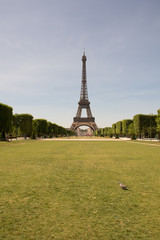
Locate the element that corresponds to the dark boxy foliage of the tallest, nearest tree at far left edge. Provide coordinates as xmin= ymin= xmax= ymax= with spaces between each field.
xmin=0 ymin=103 xmax=13 ymax=133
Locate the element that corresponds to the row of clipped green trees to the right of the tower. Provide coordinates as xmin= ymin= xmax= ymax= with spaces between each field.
xmin=94 ymin=109 xmax=160 ymax=139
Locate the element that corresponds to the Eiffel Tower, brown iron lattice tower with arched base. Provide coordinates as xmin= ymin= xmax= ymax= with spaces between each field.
xmin=70 ymin=52 xmax=98 ymax=131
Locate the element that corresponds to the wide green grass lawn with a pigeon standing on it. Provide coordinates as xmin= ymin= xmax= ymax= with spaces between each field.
xmin=0 ymin=140 xmax=160 ymax=240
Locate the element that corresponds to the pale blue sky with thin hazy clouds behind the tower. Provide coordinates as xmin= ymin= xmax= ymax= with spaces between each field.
xmin=0 ymin=0 xmax=160 ymax=127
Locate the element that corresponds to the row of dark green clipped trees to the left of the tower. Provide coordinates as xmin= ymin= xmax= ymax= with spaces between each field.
xmin=0 ymin=103 xmax=74 ymax=140
